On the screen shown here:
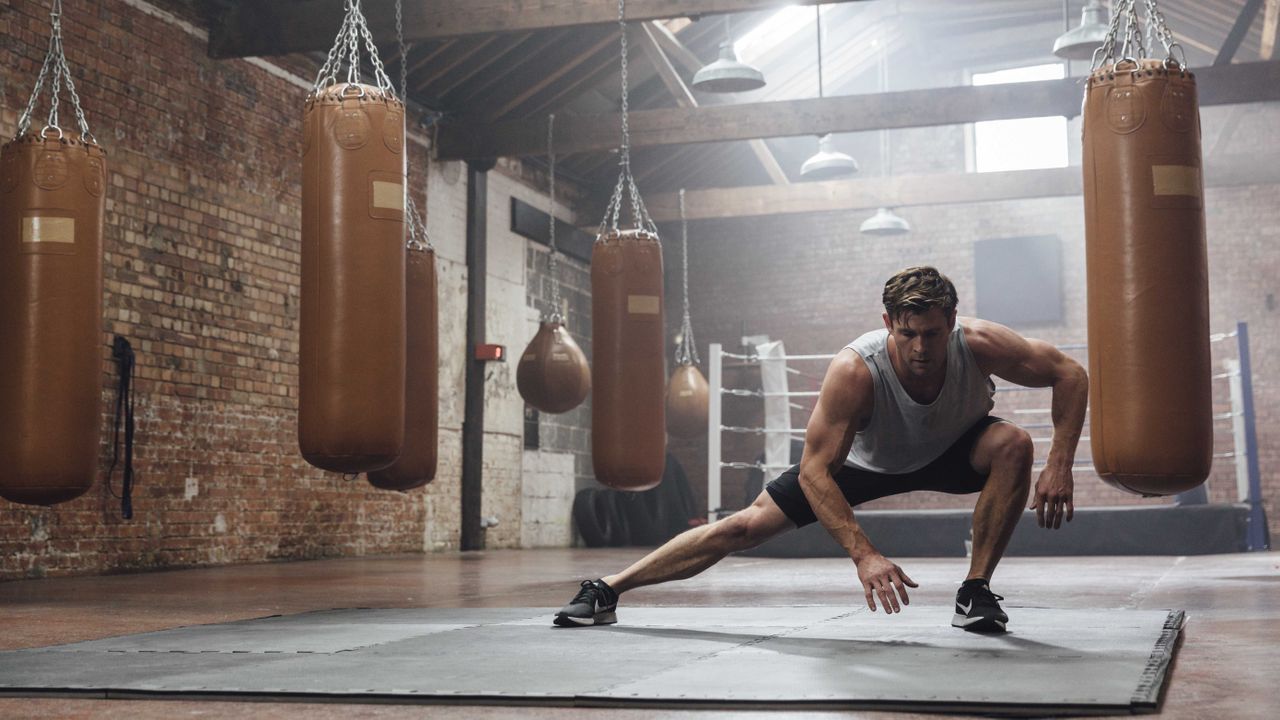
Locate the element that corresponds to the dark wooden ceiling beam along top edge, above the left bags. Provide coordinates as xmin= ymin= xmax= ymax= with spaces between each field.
xmin=209 ymin=0 xmax=863 ymax=58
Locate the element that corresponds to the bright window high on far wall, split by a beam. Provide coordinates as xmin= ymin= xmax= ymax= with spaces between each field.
xmin=973 ymin=63 xmax=1068 ymax=173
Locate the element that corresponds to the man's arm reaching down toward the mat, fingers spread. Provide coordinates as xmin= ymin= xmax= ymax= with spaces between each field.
xmin=800 ymin=350 xmax=916 ymax=612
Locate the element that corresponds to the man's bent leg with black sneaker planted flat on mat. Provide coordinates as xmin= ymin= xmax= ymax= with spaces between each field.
xmin=951 ymin=423 xmax=1034 ymax=633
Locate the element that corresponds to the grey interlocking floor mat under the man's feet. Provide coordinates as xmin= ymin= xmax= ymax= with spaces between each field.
xmin=0 ymin=605 xmax=1183 ymax=715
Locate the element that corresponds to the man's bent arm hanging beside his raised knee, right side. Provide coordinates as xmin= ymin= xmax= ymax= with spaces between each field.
xmin=964 ymin=320 xmax=1089 ymax=529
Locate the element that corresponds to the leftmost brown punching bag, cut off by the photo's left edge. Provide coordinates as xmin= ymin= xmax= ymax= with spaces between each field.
xmin=0 ymin=132 xmax=106 ymax=505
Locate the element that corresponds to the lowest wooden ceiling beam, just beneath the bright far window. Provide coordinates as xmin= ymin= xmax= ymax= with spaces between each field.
xmin=645 ymin=154 xmax=1280 ymax=223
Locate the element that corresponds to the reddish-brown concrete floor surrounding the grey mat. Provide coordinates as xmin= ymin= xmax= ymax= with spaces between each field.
xmin=0 ymin=548 xmax=1280 ymax=720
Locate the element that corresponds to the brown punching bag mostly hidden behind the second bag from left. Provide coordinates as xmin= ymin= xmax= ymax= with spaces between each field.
xmin=369 ymin=244 xmax=440 ymax=491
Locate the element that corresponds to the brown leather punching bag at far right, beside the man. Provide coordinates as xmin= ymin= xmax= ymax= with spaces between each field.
xmin=1083 ymin=60 xmax=1213 ymax=496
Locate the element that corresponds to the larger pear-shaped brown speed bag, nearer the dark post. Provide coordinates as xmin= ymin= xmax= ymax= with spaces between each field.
xmin=516 ymin=317 xmax=591 ymax=414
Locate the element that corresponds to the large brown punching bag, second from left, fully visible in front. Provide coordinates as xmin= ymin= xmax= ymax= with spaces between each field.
xmin=298 ymin=83 xmax=406 ymax=473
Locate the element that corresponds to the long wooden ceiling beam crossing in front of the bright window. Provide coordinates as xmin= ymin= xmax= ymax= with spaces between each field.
xmin=439 ymin=60 xmax=1280 ymax=160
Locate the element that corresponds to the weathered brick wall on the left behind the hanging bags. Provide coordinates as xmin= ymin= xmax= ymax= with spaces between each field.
xmin=0 ymin=0 xmax=494 ymax=579
